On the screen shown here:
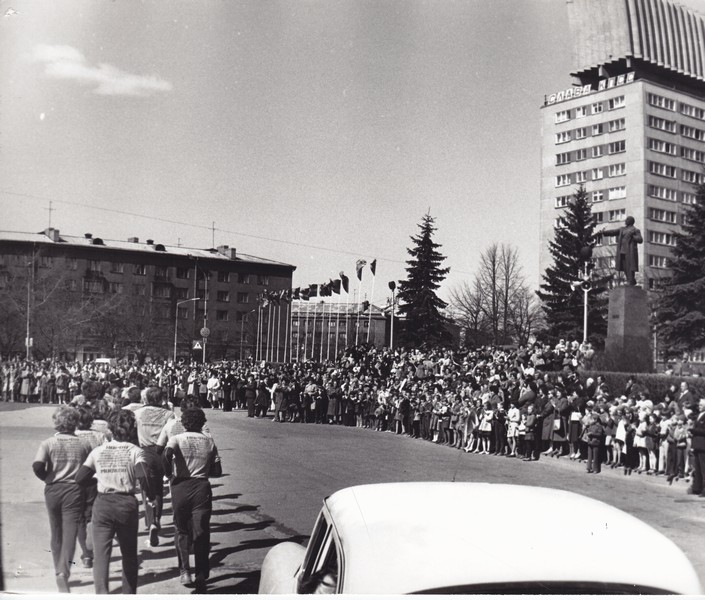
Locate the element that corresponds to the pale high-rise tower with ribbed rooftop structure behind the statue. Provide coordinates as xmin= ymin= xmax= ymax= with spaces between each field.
xmin=539 ymin=0 xmax=705 ymax=289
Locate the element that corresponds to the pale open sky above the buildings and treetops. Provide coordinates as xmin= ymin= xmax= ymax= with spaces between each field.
xmin=0 ymin=0 xmax=703 ymax=304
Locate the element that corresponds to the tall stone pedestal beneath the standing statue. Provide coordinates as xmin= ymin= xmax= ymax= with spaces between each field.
xmin=605 ymin=285 xmax=654 ymax=373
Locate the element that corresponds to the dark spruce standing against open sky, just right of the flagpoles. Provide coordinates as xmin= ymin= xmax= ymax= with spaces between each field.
xmin=399 ymin=213 xmax=451 ymax=346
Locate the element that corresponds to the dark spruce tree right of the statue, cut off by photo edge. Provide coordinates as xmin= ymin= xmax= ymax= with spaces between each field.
xmin=654 ymin=176 xmax=705 ymax=357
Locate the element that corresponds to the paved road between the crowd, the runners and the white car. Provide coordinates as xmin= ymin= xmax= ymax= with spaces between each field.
xmin=0 ymin=404 xmax=705 ymax=594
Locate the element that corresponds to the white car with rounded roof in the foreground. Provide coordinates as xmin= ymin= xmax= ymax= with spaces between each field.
xmin=259 ymin=482 xmax=703 ymax=595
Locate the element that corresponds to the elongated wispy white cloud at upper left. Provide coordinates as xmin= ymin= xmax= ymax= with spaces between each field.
xmin=32 ymin=44 xmax=172 ymax=96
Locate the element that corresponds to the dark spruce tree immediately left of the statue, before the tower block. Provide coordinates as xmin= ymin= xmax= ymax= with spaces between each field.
xmin=536 ymin=186 xmax=607 ymax=346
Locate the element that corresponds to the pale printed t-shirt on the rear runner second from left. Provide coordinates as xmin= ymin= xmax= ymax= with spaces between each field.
xmin=84 ymin=440 xmax=145 ymax=494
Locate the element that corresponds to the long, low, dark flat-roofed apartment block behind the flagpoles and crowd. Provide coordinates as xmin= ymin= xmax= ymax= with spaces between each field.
xmin=0 ymin=228 xmax=296 ymax=361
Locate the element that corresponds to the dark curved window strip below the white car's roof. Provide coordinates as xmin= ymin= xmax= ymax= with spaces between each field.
xmin=414 ymin=581 xmax=673 ymax=596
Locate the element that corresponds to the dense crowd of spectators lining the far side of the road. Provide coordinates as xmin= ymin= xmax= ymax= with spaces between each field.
xmin=0 ymin=340 xmax=705 ymax=493
